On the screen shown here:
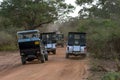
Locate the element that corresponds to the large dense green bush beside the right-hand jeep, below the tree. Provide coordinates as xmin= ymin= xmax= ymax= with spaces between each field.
xmin=78 ymin=19 xmax=120 ymax=59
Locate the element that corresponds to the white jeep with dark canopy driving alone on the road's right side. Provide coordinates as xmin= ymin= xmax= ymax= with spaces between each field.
xmin=66 ymin=32 xmax=86 ymax=58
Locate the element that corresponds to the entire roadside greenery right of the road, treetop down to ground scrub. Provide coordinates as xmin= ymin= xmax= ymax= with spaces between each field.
xmin=76 ymin=0 xmax=120 ymax=80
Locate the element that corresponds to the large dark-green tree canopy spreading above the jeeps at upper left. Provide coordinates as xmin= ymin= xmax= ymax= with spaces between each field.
xmin=0 ymin=0 xmax=74 ymax=29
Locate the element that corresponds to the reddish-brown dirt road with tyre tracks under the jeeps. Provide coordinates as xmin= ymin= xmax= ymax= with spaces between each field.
xmin=0 ymin=48 xmax=89 ymax=80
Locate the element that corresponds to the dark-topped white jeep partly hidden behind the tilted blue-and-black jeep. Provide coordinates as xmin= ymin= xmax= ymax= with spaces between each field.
xmin=41 ymin=32 xmax=56 ymax=54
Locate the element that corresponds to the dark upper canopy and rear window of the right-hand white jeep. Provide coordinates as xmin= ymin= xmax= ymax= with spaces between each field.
xmin=68 ymin=33 xmax=86 ymax=46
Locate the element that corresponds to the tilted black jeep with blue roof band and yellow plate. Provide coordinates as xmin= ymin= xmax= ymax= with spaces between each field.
xmin=17 ymin=30 xmax=48 ymax=64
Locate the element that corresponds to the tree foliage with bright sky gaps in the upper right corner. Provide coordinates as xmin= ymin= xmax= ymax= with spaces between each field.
xmin=76 ymin=0 xmax=120 ymax=19
